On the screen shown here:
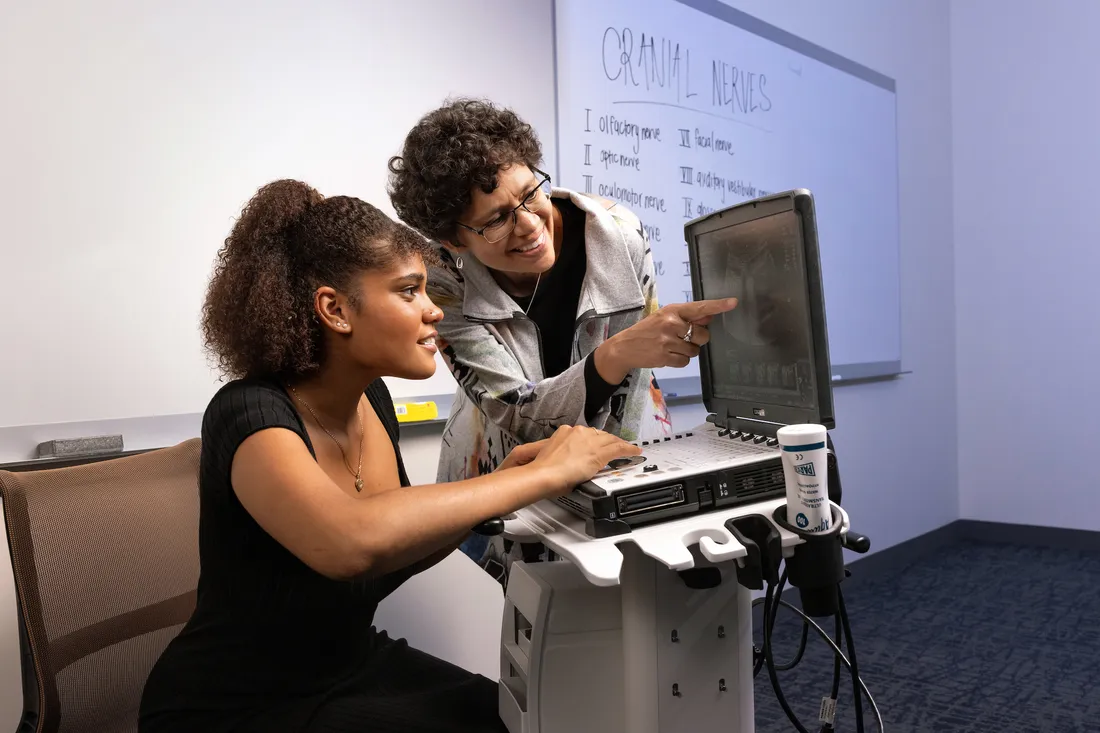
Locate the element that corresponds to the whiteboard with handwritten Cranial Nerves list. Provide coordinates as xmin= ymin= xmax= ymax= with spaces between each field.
xmin=556 ymin=0 xmax=902 ymax=394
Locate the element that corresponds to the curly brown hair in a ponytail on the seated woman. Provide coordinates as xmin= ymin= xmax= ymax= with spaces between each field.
xmin=201 ymin=180 xmax=436 ymax=380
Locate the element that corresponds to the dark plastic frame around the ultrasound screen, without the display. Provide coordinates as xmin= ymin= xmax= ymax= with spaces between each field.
xmin=684 ymin=188 xmax=836 ymax=436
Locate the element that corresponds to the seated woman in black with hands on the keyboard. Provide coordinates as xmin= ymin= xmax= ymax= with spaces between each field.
xmin=140 ymin=180 xmax=638 ymax=733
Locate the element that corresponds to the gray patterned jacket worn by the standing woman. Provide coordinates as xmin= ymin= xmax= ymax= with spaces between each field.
xmin=428 ymin=188 xmax=672 ymax=482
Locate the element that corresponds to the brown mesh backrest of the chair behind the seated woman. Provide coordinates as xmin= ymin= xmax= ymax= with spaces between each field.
xmin=0 ymin=438 xmax=199 ymax=733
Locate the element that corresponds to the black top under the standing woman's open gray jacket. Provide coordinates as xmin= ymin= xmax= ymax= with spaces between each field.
xmin=514 ymin=199 xmax=619 ymax=422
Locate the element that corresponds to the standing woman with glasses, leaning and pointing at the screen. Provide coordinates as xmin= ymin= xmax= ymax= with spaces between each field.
xmin=389 ymin=99 xmax=736 ymax=560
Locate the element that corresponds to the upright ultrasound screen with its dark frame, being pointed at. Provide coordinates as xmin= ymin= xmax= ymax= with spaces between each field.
xmin=684 ymin=189 xmax=835 ymax=434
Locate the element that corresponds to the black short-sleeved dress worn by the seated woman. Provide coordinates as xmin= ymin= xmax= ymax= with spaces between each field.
xmin=139 ymin=380 xmax=506 ymax=733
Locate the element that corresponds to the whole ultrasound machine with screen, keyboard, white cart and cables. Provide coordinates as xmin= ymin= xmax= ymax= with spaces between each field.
xmin=499 ymin=189 xmax=881 ymax=733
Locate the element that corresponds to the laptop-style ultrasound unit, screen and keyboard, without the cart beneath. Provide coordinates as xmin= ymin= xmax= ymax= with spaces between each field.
xmin=556 ymin=190 xmax=836 ymax=537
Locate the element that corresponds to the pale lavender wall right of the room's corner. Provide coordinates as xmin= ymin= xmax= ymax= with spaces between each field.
xmin=954 ymin=0 xmax=1100 ymax=530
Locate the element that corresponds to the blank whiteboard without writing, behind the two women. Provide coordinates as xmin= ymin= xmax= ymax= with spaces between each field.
xmin=0 ymin=0 xmax=554 ymax=442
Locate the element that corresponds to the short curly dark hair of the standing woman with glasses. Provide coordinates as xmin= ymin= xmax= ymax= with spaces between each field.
xmin=389 ymin=99 xmax=542 ymax=241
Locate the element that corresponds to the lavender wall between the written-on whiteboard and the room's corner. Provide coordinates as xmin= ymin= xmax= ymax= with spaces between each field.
xmin=695 ymin=0 xmax=958 ymax=549
